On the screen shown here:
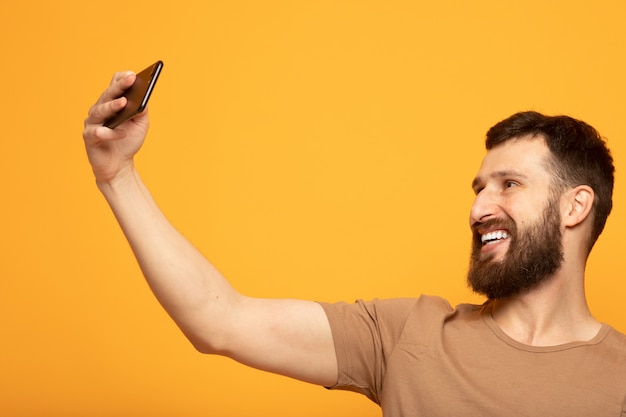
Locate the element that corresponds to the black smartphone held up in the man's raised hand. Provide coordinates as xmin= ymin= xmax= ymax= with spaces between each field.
xmin=104 ymin=61 xmax=163 ymax=129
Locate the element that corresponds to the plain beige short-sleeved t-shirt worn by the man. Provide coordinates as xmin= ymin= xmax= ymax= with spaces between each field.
xmin=321 ymin=296 xmax=626 ymax=417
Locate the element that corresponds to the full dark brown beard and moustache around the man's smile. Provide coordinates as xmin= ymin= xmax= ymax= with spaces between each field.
xmin=467 ymin=199 xmax=563 ymax=299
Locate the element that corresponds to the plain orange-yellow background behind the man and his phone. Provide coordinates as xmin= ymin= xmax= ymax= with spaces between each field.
xmin=0 ymin=0 xmax=626 ymax=417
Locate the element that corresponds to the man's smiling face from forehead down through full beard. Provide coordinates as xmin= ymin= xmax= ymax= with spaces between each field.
xmin=468 ymin=138 xmax=563 ymax=299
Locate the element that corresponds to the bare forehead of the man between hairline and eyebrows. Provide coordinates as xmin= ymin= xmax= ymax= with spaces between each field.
xmin=474 ymin=137 xmax=551 ymax=182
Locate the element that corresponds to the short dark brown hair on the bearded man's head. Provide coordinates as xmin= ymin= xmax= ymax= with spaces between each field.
xmin=485 ymin=111 xmax=615 ymax=250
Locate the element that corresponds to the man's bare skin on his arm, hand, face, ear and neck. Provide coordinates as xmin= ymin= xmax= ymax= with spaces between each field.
xmin=83 ymin=72 xmax=600 ymax=386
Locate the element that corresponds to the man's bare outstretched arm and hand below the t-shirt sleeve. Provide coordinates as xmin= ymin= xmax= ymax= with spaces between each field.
xmin=83 ymin=72 xmax=337 ymax=386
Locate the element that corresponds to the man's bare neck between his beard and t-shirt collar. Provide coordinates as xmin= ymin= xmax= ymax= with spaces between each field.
xmin=492 ymin=265 xmax=602 ymax=346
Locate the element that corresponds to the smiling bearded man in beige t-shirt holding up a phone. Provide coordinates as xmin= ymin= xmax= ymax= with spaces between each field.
xmin=83 ymin=72 xmax=626 ymax=417
